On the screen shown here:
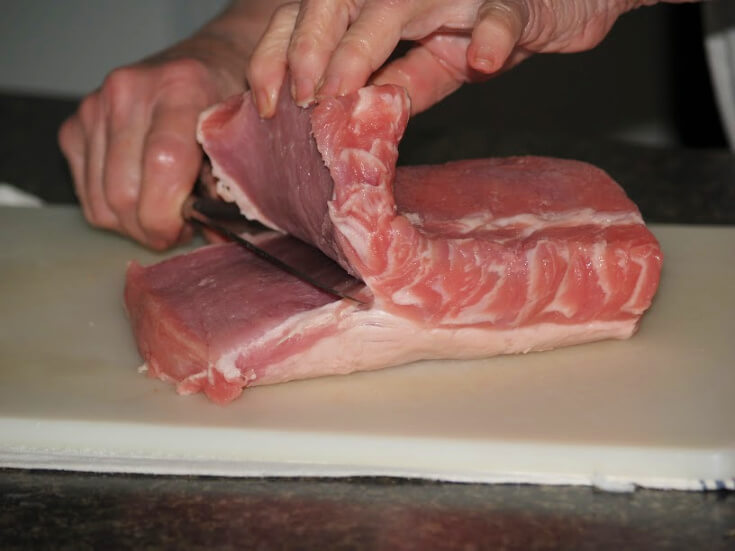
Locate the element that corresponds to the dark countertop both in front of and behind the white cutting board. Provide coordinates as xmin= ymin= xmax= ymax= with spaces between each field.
xmin=0 ymin=94 xmax=735 ymax=550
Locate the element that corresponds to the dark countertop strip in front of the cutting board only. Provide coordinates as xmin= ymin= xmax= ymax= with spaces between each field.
xmin=0 ymin=470 xmax=735 ymax=550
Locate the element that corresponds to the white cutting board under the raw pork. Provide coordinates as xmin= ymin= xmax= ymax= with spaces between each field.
xmin=0 ymin=207 xmax=735 ymax=490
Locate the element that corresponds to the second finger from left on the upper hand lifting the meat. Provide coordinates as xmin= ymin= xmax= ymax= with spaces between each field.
xmin=288 ymin=0 xmax=361 ymax=106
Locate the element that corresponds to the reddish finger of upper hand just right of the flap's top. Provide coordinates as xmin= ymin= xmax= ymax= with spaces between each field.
xmin=372 ymin=46 xmax=465 ymax=115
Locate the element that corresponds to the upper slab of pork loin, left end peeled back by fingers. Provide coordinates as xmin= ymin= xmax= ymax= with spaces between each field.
xmin=199 ymin=86 xmax=662 ymax=330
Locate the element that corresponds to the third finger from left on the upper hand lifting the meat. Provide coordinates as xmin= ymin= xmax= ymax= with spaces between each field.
xmin=317 ymin=1 xmax=414 ymax=97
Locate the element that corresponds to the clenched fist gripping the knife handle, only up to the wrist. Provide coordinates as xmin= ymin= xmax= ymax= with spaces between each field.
xmin=59 ymin=53 xmax=234 ymax=249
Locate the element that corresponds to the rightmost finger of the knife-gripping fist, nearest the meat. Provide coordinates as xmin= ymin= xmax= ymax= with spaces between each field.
xmin=138 ymin=105 xmax=202 ymax=249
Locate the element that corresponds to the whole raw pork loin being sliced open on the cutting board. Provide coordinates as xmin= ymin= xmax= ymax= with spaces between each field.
xmin=125 ymin=86 xmax=662 ymax=403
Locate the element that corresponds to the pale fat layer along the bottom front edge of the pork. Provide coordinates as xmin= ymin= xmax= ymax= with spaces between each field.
xmin=134 ymin=274 xmax=639 ymax=404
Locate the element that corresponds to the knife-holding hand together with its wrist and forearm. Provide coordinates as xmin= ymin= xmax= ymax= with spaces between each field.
xmin=59 ymin=0 xmax=283 ymax=249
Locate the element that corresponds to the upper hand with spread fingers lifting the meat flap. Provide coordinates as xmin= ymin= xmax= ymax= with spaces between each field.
xmin=248 ymin=0 xmax=687 ymax=117
